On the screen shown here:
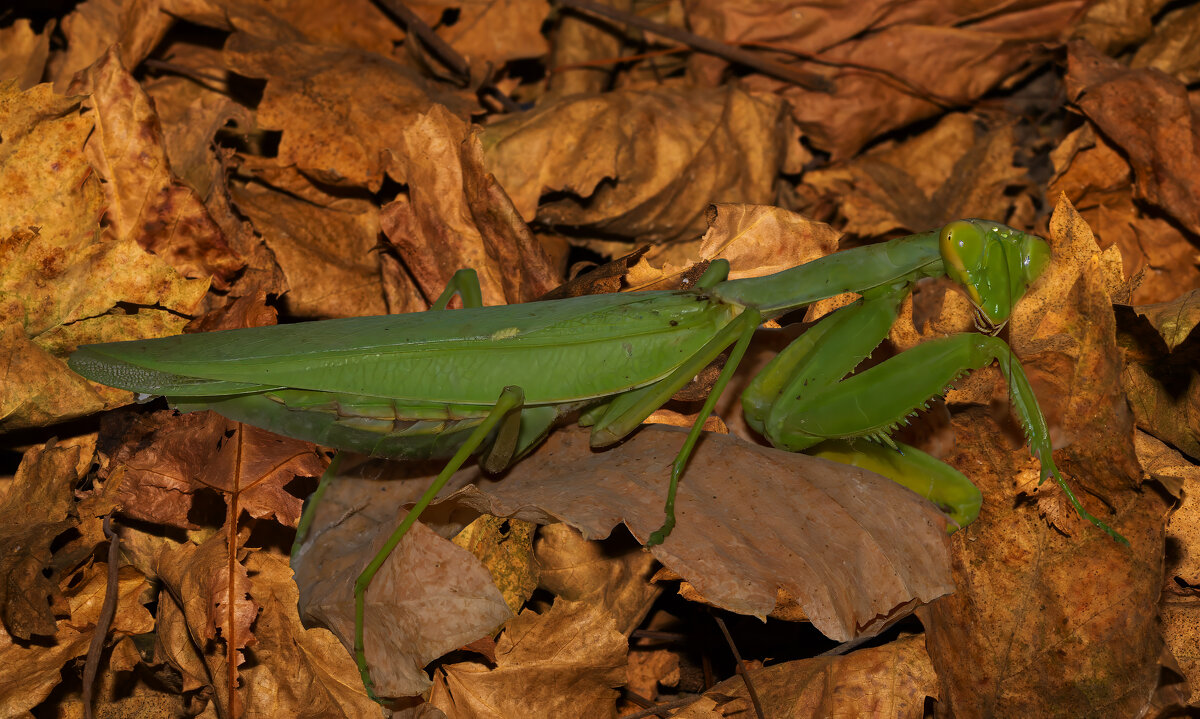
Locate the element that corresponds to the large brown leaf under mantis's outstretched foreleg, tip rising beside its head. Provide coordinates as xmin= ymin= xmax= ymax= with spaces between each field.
xmin=918 ymin=200 xmax=1166 ymax=717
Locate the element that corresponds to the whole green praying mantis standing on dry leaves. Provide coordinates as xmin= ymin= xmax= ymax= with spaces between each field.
xmin=70 ymin=220 xmax=1124 ymax=697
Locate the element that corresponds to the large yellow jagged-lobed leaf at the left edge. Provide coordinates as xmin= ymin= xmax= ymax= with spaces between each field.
xmin=0 ymin=83 xmax=208 ymax=430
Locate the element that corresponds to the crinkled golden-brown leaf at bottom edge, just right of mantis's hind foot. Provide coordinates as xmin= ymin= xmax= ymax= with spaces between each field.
xmin=430 ymin=599 xmax=629 ymax=719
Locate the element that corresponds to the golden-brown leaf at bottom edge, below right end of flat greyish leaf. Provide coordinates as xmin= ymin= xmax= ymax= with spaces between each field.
xmin=674 ymin=635 xmax=938 ymax=719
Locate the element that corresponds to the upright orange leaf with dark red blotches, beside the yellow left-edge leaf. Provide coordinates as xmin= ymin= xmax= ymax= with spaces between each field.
xmin=71 ymin=48 xmax=245 ymax=289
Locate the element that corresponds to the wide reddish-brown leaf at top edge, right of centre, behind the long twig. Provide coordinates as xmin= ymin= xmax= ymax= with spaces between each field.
xmin=688 ymin=0 xmax=1085 ymax=161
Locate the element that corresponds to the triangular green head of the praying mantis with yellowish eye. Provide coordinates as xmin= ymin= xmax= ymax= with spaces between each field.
xmin=940 ymin=220 xmax=1050 ymax=331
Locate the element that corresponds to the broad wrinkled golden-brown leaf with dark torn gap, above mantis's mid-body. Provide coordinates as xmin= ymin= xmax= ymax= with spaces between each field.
xmin=481 ymin=88 xmax=787 ymax=241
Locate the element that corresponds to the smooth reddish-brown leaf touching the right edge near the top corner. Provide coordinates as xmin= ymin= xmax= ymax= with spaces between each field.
xmin=1067 ymin=41 xmax=1200 ymax=233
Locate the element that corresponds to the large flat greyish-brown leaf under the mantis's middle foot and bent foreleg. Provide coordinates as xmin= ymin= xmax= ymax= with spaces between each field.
xmin=309 ymin=426 xmax=949 ymax=658
